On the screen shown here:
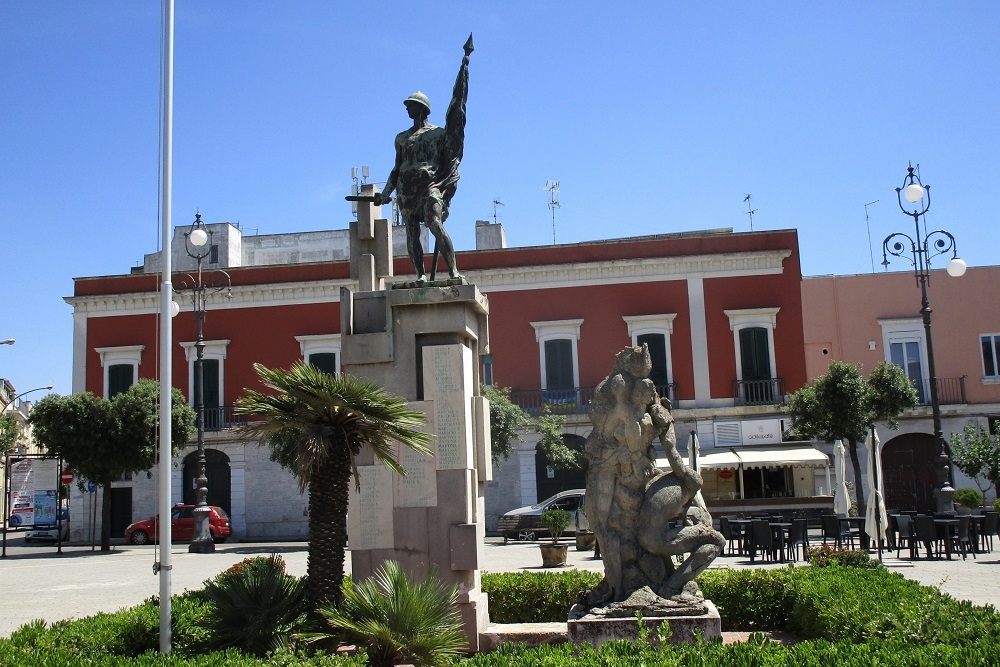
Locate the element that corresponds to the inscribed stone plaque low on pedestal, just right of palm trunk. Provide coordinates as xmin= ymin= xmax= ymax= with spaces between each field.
xmin=347 ymin=463 xmax=395 ymax=551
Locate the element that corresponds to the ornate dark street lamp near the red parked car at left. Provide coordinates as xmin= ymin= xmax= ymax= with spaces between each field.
xmin=175 ymin=213 xmax=232 ymax=554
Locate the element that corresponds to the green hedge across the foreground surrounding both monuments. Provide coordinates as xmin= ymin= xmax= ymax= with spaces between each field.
xmin=7 ymin=566 xmax=1000 ymax=667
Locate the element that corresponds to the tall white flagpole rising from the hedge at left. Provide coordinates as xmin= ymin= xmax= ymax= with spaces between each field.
xmin=158 ymin=0 xmax=174 ymax=654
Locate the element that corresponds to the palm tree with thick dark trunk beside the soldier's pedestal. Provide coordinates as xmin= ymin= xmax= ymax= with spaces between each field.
xmin=236 ymin=361 xmax=433 ymax=609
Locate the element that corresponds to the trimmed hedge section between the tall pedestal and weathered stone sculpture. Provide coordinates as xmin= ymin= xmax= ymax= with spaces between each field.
xmin=482 ymin=570 xmax=604 ymax=623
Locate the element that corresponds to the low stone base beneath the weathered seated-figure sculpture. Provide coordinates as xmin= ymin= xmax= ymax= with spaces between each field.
xmin=566 ymin=600 xmax=722 ymax=648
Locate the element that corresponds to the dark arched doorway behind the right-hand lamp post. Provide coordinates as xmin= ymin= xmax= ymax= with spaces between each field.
xmin=882 ymin=433 xmax=940 ymax=512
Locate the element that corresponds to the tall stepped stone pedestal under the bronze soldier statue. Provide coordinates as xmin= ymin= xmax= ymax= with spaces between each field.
xmin=341 ymin=285 xmax=492 ymax=651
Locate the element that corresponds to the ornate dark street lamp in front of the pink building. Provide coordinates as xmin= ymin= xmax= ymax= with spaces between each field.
xmin=882 ymin=165 xmax=965 ymax=512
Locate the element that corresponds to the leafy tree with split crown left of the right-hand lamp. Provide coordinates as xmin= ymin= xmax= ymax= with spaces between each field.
xmin=788 ymin=361 xmax=917 ymax=515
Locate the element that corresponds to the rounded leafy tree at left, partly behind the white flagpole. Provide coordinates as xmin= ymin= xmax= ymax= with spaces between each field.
xmin=29 ymin=379 xmax=195 ymax=551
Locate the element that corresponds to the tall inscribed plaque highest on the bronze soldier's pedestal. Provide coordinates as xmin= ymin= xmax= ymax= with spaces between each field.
xmin=424 ymin=345 xmax=475 ymax=470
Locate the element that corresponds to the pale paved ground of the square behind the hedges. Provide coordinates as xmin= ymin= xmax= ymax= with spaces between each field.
xmin=0 ymin=534 xmax=1000 ymax=637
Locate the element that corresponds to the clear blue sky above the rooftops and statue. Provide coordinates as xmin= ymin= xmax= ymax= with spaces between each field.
xmin=0 ymin=0 xmax=1000 ymax=398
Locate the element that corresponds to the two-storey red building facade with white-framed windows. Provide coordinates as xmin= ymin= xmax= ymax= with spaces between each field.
xmin=67 ymin=222 xmax=822 ymax=538
